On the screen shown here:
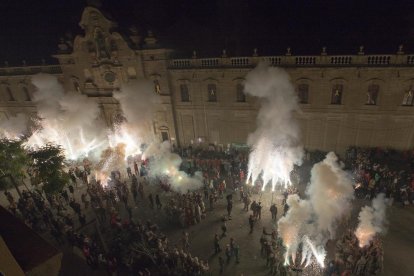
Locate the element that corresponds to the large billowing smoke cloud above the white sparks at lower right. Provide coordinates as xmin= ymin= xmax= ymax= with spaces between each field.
xmin=278 ymin=152 xmax=354 ymax=267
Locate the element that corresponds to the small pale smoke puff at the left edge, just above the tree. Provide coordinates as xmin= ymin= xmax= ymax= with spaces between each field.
xmin=0 ymin=113 xmax=29 ymax=139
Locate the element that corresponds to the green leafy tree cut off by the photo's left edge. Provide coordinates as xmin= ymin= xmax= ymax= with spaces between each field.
xmin=0 ymin=138 xmax=29 ymax=196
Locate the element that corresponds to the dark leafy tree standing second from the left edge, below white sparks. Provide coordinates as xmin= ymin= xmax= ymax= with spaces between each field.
xmin=29 ymin=144 xmax=69 ymax=194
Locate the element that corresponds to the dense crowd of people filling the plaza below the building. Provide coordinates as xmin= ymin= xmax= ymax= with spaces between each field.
xmin=0 ymin=147 xmax=414 ymax=275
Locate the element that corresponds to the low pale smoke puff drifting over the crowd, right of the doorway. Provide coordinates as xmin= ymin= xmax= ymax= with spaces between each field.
xmin=143 ymin=141 xmax=203 ymax=192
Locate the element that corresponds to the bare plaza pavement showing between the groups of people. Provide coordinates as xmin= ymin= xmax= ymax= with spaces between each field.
xmin=0 ymin=180 xmax=414 ymax=276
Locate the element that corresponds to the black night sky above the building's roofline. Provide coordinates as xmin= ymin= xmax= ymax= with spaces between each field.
xmin=0 ymin=0 xmax=414 ymax=65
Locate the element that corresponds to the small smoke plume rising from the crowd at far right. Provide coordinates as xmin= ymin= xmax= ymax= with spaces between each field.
xmin=355 ymin=194 xmax=386 ymax=247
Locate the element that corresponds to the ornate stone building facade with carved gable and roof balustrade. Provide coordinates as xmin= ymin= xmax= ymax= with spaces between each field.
xmin=0 ymin=7 xmax=414 ymax=153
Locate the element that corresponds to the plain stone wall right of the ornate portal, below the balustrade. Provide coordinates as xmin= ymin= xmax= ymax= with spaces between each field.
xmin=170 ymin=61 xmax=414 ymax=153
